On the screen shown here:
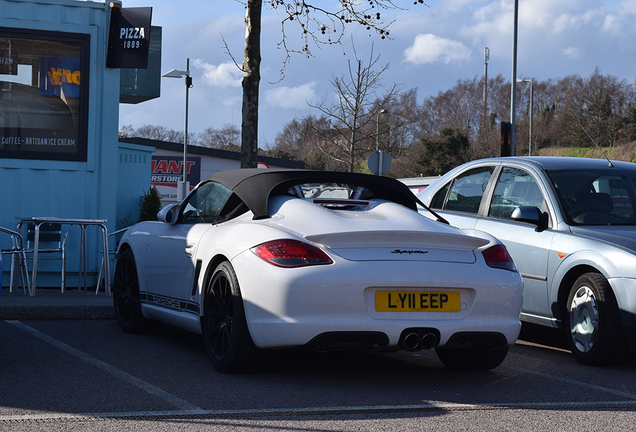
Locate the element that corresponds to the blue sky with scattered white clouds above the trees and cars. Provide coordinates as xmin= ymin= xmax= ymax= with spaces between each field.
xmin=120 ymin=0 xmax=636 ymax=148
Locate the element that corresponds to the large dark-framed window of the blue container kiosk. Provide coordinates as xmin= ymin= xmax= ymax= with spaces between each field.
xmin=0 ymin=27 xmax=90 ymax=161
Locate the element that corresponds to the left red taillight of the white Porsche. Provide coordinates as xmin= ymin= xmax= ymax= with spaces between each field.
xmin=252 ymin=240 xmax=333 ymax=267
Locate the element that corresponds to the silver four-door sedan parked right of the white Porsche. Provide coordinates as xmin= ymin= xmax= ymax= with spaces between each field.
xmin=418 ymin=157 xmax=636 ymax=365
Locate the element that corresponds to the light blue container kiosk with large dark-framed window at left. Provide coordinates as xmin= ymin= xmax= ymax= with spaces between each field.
xmin=0 ymin=0 xmax=120 ymax=286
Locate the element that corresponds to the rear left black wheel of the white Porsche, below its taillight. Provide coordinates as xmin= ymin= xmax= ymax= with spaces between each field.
xmin=202 ymin=261 xmax=264 ymax=373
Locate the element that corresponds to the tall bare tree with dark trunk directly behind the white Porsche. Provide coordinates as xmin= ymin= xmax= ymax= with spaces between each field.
xmin=236 ymin=0 xmax=424 ymax=168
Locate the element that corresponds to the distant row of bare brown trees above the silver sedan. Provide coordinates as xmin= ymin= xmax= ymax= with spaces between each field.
xmin=268 ymin=68 xmax=636 ymax=177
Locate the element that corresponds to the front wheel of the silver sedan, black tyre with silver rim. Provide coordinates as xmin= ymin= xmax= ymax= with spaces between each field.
xmin=565 ymin=272 xmax=627 ymax=366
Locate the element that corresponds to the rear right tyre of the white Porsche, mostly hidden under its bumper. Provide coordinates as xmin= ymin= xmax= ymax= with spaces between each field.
xmin=435 ymin=345 xmax=508 ymax=371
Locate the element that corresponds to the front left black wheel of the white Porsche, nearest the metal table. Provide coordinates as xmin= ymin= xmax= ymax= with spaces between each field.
xmin=112 ymin=249 xmax=150 ymax=333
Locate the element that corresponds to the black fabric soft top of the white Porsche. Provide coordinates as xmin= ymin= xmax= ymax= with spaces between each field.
xmin=206 ymin=168 xmax=423 ymax=219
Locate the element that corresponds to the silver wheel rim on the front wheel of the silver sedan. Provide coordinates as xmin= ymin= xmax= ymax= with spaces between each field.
xmin=569 ymin=286 xmax=599 ymax=353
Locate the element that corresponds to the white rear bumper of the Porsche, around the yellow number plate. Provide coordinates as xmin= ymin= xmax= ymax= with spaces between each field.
xmin=232 ymin=252 xmax=523 ymax=349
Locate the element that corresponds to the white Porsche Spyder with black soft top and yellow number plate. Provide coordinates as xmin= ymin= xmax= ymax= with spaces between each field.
xmin=113 ymin=169 xmax=523 ymax=372
